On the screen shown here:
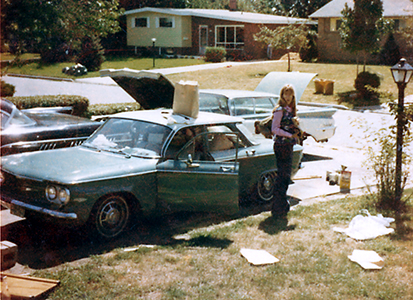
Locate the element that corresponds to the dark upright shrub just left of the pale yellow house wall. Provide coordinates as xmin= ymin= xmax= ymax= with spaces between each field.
xmin=77 ymin=36 xmax=105 ymax=72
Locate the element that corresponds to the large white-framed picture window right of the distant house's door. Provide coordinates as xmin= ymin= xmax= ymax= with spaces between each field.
xmin=215 ymin=25 xmax=244 ymax=50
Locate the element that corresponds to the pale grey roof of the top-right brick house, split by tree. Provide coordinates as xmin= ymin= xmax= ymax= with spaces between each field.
xmin=309 ymin=0 xmax=413 ymax=19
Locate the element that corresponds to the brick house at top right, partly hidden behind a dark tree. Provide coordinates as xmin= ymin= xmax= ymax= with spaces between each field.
xmin=309 ymin=0 xmax=413 ymax=63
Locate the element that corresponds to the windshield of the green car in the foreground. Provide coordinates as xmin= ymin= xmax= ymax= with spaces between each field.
xmin=83 ymin=118 xmax=171 ymax=158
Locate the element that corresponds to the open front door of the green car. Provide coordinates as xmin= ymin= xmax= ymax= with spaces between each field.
xmin=157 ymin=132 xmax=239 ymax=214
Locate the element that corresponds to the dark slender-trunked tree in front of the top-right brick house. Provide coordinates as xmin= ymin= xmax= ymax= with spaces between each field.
xmin=339 ymin=0 xmax=386 ymax=71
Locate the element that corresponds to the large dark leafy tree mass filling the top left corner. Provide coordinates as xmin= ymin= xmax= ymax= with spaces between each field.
xmin=2 ymin=0 xmax=121 ymax=62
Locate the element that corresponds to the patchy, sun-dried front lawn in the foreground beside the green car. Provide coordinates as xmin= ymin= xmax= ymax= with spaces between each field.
xmin=34 ymin=191 xmax=413 ymax=300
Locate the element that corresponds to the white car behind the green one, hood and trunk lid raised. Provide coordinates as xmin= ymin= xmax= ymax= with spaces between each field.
xmin=100 ymin=68 xmax=337 ymax=142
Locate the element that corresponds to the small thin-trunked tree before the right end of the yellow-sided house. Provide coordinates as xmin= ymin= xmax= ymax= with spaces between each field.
xmin=254 ymin=24 xmax=307 ymax=72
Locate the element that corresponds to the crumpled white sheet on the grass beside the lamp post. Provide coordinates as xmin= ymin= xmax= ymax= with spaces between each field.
xmin=333 ymin=213 xmax=394 ymax=240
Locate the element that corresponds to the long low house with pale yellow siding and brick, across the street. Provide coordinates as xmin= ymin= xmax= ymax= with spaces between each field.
xmin=125 ymin=1 xmax=316 ymax=59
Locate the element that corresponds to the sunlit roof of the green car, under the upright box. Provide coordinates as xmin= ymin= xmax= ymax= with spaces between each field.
xmin=110 ymin=109 xmax=243 ymax=128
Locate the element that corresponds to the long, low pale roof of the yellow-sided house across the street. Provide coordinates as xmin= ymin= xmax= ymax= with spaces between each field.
xmin=124 ymin=7 xmax=316 ymax=24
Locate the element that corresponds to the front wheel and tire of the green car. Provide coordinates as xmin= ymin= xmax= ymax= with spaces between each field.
xmin=90 ymin=195 xmax=130 ymax=239
